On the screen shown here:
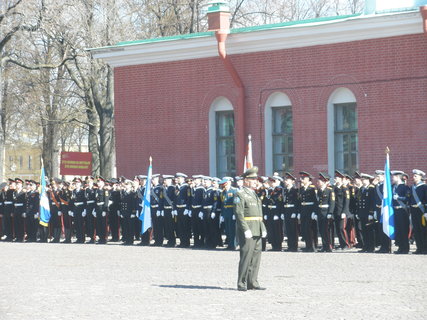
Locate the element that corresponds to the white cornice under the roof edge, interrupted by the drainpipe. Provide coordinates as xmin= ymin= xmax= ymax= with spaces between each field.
xmin=90 ymin=11 xmax=423 ymax=67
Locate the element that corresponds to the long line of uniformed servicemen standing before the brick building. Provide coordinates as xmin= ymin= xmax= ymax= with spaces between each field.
xmin=0 ymin=169 xmax=427 ymax=254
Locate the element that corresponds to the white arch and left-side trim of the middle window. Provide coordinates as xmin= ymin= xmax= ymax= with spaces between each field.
xmin=264 ymin=92 xmax=292 ymax=176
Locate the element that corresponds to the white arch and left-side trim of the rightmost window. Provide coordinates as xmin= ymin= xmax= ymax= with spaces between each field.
xmin=327 ymin=87 xmax=357 ymax=176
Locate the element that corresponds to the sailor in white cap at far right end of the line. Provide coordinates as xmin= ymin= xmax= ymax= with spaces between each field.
xmin=410 ymin=169 xmax=427 ymax=254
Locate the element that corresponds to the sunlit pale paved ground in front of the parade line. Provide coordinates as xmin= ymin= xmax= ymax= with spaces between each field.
xmin=0 ymin=242 xmax=427 ymax=319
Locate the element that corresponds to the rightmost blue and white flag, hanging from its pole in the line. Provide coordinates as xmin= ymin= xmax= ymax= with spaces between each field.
xmin=381 ymin=153 xmax=394 ymax=240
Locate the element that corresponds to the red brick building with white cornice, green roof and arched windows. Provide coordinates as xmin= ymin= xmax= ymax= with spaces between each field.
xmin=92 ymin=4 xmax=427 ymax=176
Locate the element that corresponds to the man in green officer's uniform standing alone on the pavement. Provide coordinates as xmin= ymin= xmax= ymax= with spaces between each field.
xmin=234 ymin=167 xmax=267 ymax=291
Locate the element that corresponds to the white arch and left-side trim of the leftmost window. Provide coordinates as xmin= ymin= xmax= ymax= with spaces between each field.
xmin=209 ymin=97 xmax=234 ymax=177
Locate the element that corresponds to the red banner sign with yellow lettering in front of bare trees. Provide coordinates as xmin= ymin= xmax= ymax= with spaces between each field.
xmin=60 ymin=152 xmax=92 ymax=176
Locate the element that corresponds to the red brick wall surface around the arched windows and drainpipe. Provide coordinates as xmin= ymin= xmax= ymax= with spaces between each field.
xmin=115 ymin=34 xmax=427 ymax=176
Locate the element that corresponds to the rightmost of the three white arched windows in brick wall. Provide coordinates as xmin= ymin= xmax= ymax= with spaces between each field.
xmin=327 ymin=88 xmax=359 ymax=175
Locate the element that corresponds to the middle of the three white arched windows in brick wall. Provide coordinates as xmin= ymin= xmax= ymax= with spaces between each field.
xmin=264 ymin=92 xmax=294 ymax=175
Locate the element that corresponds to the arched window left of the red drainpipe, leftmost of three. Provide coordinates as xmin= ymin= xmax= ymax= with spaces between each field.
xmin=209 ymin=97 xmax=236 ymax=177
